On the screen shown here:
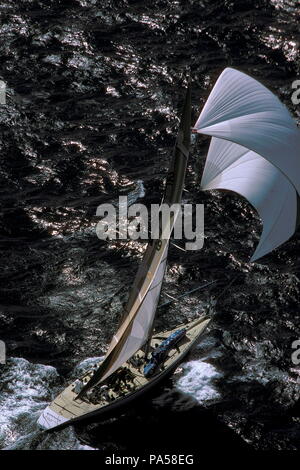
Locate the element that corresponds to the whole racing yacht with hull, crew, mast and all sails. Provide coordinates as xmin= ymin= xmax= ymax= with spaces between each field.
xmin=38 ymin=68 xmax=300 ymax=430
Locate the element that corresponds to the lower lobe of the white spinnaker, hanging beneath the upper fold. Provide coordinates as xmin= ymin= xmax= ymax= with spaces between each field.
xmin=201 ymin=137 xmax=297 ymax=261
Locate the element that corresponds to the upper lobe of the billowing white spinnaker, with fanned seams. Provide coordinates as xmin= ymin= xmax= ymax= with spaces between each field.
xmin=195 ymin=68 xmax=300 ymax=194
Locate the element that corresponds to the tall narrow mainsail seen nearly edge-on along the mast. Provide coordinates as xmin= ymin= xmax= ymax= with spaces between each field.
xmin=79 ymin=83 xmax=191 ymax=396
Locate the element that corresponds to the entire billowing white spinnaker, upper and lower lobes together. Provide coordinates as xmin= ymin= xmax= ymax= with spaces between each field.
xmin=194 ymin=68 xmax=300 ymax=261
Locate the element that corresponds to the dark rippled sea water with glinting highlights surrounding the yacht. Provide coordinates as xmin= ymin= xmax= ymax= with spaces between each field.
xmin=0 ymin=0 xmax=300 ymax=454
